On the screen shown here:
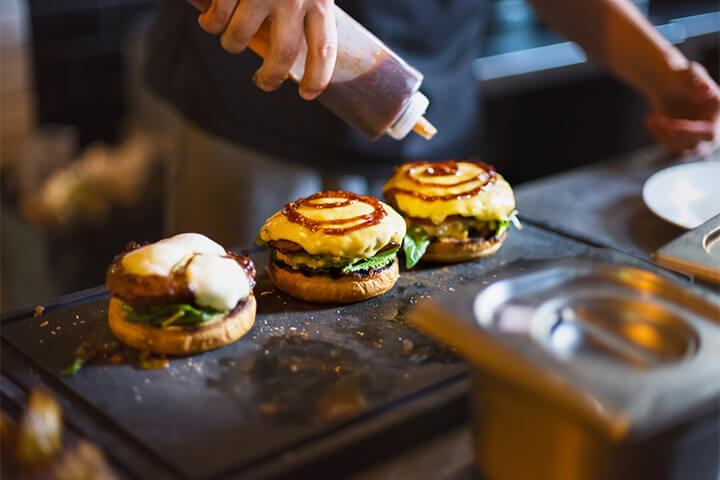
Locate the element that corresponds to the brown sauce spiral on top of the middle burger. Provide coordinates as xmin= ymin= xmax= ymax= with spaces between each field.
xmin=281 ymin=192 xmax=387 ymax=235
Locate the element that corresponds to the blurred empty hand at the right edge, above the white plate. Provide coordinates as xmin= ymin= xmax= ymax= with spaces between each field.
xmin=645 ymin=62 xmax=720 ymax=156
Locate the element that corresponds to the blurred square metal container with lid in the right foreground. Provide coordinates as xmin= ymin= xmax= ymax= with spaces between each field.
xmin=411 ymin=253 xmax=720 ymax=480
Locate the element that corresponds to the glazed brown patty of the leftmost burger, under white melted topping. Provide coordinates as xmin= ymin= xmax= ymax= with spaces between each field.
xmin=106 ymin=243 xmax=255 ymax=310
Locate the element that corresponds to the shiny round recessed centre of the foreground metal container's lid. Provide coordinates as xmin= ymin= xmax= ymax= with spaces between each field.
xmin=474 ymin=266 xmax=698 ymax=368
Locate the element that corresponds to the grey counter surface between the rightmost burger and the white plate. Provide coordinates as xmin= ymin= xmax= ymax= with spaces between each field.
xmin=515 ymin=148 xmax=720 ymax=258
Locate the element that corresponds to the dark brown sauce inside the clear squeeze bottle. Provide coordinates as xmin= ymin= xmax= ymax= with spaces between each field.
xmin=318 ymin=54 xmax=419 ymax=140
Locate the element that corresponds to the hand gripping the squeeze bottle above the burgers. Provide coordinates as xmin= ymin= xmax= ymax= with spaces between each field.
xmin=189 ymin=0 xmax=337 ymax=100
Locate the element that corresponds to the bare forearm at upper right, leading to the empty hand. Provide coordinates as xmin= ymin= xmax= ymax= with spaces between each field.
xmin=529 ymin=0 xmax=687 ymax=97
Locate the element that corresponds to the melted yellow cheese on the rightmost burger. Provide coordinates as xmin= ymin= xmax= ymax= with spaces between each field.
xmin=383 ymin=162 xmax=515 ymax=225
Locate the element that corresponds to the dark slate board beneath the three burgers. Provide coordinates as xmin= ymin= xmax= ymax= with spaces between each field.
xmin=2 ymin=226 xmax=588 ymax=479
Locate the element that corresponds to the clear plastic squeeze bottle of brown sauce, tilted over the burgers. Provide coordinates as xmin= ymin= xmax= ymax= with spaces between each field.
xmin=191 ymin=0 xmax=437 ymax=140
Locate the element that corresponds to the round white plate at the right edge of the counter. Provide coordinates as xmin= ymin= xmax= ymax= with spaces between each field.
xmin=643 ymin=161 xmax=720 ymax=229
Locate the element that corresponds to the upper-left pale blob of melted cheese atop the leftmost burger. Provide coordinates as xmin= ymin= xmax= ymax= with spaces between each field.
xmin=122 ymin=233 xmax=225 ymax=276
